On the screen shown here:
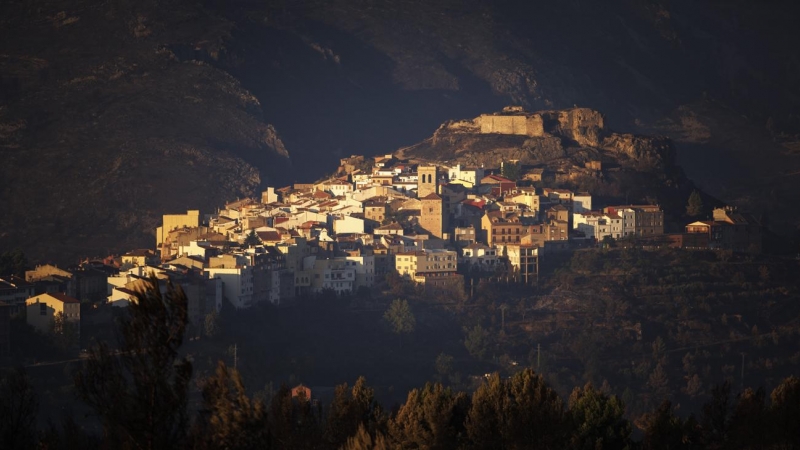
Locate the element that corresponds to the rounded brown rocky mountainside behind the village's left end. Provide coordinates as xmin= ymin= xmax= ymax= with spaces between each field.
xmin=0 ymin=2 xmax=291 ymax=261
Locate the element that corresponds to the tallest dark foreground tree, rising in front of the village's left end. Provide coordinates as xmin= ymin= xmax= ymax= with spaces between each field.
xmin=75 ymin=276 xmax=192 ymax=449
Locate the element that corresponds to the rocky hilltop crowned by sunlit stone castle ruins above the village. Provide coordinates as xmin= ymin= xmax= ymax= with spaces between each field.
xmin=400 ymin=107 xmax=675 ymax=176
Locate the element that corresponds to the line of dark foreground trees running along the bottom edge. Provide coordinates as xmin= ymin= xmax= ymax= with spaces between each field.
xmin=6 ymin=279 xmax=800 ymax=450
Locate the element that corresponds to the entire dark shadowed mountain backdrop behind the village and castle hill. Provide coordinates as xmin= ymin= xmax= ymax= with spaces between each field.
xmin=0 ymin=0 xmax=800 ymax=258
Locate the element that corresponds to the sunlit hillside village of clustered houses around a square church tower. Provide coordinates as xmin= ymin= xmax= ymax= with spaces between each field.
xmin=0 ymin=154 xmax=761 ymax=342
